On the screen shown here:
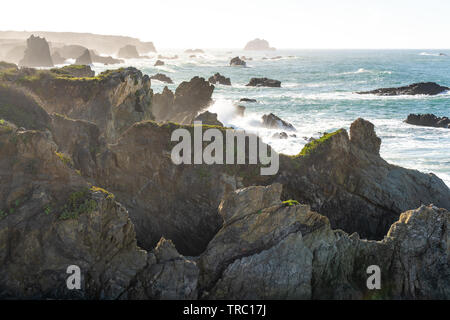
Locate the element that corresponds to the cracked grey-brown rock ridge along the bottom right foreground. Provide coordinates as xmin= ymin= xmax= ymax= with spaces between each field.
xmin=199 ymin=184 xmax=450 ymax=299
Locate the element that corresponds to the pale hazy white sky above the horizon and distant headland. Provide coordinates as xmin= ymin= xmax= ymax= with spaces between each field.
xmin=0 ymin=0 xmax=450 ymax=48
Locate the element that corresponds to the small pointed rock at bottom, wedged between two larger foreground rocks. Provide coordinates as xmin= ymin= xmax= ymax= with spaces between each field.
xmin=127 ymin=238 xmax=199 ymax=300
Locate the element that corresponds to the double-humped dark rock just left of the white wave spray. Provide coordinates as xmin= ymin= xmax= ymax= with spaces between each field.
xmin=152 ymin=77 xmax=214 ymax=124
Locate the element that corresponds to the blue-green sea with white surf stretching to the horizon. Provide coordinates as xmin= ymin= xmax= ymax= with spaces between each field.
xmin=94 ymin=50 xmax=450 ymax=186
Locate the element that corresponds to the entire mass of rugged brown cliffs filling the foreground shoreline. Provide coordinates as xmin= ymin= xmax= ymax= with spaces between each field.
xmin=0 ymin=65 xmax=450 ymax=299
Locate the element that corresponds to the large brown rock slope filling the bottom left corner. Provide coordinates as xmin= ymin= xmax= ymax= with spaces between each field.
xmin=0 ymin=124 xmax=146 ymax=299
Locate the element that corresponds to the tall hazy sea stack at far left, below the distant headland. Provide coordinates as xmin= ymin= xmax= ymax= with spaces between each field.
xmin=19 ymin=35 xmax=53 ymax=67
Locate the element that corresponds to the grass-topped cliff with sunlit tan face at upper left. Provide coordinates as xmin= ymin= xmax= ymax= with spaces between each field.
xmin=0 ymin=68 xmax=153 ymax=143
